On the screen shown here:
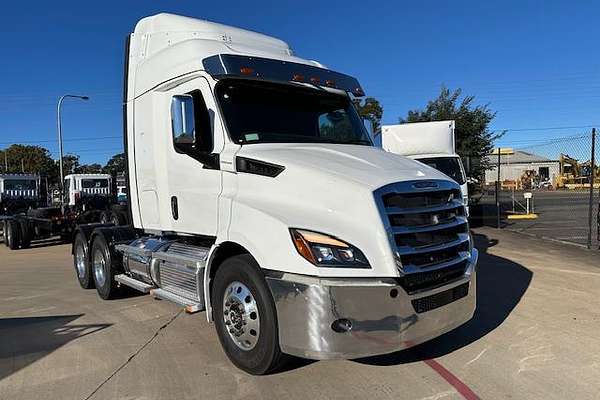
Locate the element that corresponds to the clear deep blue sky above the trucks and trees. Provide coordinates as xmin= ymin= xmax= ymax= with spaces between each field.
xmin=0 ymin=0 xmax=600 ymax=163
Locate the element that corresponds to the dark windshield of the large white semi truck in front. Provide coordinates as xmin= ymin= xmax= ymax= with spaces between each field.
xmin=216 ymin=80 xmax=372 ymax=146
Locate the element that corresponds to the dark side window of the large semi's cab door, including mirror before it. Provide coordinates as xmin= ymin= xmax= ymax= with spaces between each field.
xmin=171 ymin=90 xmax=214 ymax=156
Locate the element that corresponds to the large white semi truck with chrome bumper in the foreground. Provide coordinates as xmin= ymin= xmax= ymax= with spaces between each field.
xmin=73 ymin=14 xmax=477 ymax=374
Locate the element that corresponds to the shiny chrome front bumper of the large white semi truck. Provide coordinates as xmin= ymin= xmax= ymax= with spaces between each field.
xmin=266 ymin=249 xmax=478 ymax=359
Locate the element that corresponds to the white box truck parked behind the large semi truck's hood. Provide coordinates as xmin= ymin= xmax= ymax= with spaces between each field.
xmin=381 ymin=121 xmax=469 ymax=213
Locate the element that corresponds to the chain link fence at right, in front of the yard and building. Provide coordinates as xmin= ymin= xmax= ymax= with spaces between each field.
xmin=467 ymin=130 xmax=600 ymax=249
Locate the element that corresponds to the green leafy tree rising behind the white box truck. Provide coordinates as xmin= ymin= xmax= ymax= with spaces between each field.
xmin=400 ymin=86 xmax=504 ymax=179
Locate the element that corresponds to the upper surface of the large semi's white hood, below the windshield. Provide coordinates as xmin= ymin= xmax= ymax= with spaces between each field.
xmin=238 ymin=143 xmax=448 ymax=190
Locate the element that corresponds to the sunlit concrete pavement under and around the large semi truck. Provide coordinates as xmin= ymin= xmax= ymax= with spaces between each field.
xmin=0 ymin=228 xmax=600 ymax=400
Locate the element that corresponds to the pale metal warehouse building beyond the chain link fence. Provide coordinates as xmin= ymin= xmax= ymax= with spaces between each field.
xmin=485 ymin=150 xmax=560 ymax=185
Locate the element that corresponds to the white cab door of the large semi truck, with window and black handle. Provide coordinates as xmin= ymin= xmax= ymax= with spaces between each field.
xmin=165 ymin=78 xmax=221 ymax=236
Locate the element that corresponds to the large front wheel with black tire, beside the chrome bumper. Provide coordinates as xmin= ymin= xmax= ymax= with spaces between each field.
xmin=212 ymin=254 xmax=284 ymax=375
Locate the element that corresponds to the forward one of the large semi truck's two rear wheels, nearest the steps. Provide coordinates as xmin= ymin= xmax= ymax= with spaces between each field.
xmin=90 ymin=235 xmax=120 ymax=300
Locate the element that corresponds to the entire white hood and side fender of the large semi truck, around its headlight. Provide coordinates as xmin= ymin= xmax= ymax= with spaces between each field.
xmin=230 ymin=144 xmax=460 ymax=277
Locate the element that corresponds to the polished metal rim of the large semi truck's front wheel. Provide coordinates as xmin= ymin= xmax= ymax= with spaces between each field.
xmin=223 ymin=281 xmax=260 ymax=351
